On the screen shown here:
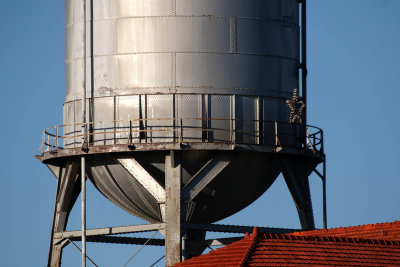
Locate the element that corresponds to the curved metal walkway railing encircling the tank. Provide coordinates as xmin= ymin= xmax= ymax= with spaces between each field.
xmin=37 ymin=118 xmax=323 ymax=155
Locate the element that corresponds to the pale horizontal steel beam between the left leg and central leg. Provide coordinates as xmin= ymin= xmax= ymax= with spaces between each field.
xmin=54 ymin=223 xmax=165 ymax=239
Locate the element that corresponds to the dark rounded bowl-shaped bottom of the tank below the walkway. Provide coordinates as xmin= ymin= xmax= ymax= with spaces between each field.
xmin=88 ymin=151 xmax=280 ymax=223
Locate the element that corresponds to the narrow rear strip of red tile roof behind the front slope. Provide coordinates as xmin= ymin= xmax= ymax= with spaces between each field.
xmin=293 ymin=221 xmax=400 ymax=241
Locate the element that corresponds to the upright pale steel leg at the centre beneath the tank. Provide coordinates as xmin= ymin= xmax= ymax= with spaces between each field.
xmin=165 ymin=151 xmax=182 ymax=266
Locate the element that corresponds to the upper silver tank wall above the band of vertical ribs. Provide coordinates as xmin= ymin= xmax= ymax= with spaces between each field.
xmin=66 ymin=0 xmax=299 ymax=99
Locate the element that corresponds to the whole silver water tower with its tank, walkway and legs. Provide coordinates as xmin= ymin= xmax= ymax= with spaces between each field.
xmin=38 ymin=0 xmax=326 ymax=266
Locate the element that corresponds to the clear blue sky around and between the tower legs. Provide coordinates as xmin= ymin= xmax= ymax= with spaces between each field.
xmin=0 ymin=0 xmax=400 ymax=267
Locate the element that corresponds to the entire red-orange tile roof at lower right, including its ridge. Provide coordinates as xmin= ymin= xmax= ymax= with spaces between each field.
xmin=175 ymin=222 xmax=400 ymax=267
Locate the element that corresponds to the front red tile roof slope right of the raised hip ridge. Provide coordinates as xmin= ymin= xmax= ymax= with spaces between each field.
xmin=247 ymin=235 xmax=400 ymax=266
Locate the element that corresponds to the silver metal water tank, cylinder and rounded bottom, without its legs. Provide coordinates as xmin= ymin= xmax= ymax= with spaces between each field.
xmin=57 ymin=0 xmax=310 ymax=222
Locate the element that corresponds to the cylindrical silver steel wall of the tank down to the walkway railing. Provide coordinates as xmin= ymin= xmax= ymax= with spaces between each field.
xmin=64 ymin=0 xmax=299 ymax=145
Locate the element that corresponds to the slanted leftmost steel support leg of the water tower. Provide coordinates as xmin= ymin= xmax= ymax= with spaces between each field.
xmin=47 ymin=162 xmax=80 ymax=267
